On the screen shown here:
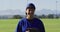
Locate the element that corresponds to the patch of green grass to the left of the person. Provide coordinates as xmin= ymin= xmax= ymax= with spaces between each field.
xmin=0 ymin=19 xmax=18 ymax=32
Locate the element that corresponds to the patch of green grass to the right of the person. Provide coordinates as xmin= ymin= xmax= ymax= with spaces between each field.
xmin=42 ymin=19 xmax=60 ymax=32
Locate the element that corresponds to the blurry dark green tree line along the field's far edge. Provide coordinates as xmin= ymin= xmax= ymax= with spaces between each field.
xmin=13 ymin=14 xmax=60 ymax=19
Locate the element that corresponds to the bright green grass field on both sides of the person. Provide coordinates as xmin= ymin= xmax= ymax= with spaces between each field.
xmin=0 ymin=19 xmax=60 ymax=32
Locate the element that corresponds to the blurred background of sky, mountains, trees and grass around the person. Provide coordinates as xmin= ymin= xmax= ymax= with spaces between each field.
xmin=0 ymin=0 xmax=60 ymax=32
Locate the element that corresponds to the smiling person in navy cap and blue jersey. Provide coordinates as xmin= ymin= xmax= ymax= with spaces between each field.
xmin=16 ymin=3 xmax=45 ymax=32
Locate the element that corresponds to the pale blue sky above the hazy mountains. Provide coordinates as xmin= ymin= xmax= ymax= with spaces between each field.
xmin=0 ymin=0 xmax=60 ymax=14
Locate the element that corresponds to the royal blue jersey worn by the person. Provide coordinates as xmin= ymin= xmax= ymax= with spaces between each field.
xmin=16 ymin=18 xmax=45 ymax=32
